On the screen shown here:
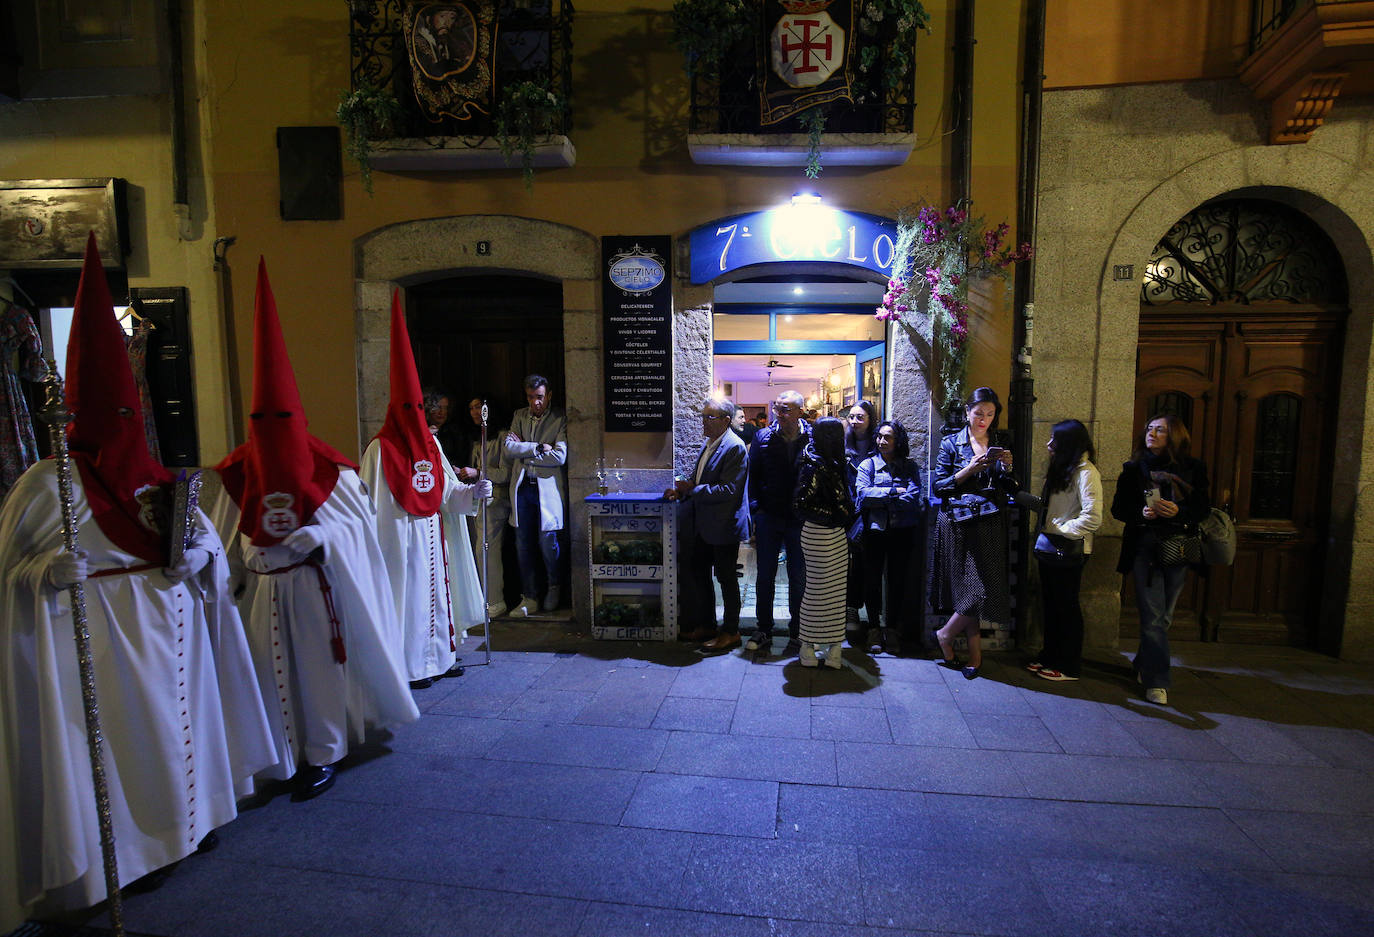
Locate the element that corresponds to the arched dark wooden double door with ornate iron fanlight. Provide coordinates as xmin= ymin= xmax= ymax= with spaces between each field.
xmin=1123 ymin=198 xmax=1348 ymax=647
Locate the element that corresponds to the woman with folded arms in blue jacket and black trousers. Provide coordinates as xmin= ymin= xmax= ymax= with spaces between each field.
xmin=855 ymin=419 xmax=925 ymax=654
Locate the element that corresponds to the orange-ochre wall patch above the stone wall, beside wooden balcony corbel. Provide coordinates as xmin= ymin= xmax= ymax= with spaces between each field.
xmin=1044 ymin=0 xmax=1250 ymax=88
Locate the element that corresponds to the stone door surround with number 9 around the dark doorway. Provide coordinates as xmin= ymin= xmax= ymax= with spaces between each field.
xmin=353 ymin=214 xmax=605 ymax=621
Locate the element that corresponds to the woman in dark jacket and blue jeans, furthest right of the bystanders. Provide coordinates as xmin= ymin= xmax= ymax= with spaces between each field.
xmin=1112 ymin=416 xmax=1212 ymax=706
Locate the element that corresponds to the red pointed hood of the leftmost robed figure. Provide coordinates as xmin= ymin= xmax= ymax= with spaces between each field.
xmin=66 ymin=231 xmax=172 ymax=563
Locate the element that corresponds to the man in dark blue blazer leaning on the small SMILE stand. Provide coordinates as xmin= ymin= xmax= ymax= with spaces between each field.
xmin=665 ymin=400 xmax=749 ymax=651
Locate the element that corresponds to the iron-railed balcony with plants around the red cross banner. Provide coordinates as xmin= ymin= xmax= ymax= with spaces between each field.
xmin=687 ymin=5 xmax=916 ymax=166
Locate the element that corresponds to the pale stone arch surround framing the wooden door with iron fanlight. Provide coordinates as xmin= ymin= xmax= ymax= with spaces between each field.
xmin=1088 ymin=166 xmax=1374 ymax=658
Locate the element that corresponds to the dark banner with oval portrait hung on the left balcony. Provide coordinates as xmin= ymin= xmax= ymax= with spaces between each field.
xmin=404 ymin=0 xmax=496 ymax=124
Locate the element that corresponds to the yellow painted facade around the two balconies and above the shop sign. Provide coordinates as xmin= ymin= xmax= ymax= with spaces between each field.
xmin=0 ymin=0 xmax=1022 ymax=462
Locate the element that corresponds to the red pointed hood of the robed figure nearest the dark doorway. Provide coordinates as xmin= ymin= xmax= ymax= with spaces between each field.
xmin=376 ymin=290 xmax=444 ymax=517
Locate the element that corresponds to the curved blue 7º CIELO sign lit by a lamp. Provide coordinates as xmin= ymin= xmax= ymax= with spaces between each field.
xmin=690 ymin=205 xmax=897 ymax=283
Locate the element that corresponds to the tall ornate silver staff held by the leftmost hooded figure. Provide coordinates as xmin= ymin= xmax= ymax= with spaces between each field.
xmin=43 ymin=359 xmax=124 ymax=937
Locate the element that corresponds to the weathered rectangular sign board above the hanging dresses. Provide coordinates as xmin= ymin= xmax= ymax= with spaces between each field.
xmin=0 ymin=179 xmax=129 ymax=269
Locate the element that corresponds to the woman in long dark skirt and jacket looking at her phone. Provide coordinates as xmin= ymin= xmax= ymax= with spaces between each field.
xmin=930 ymin=387 xmax=1015 ymax=680
